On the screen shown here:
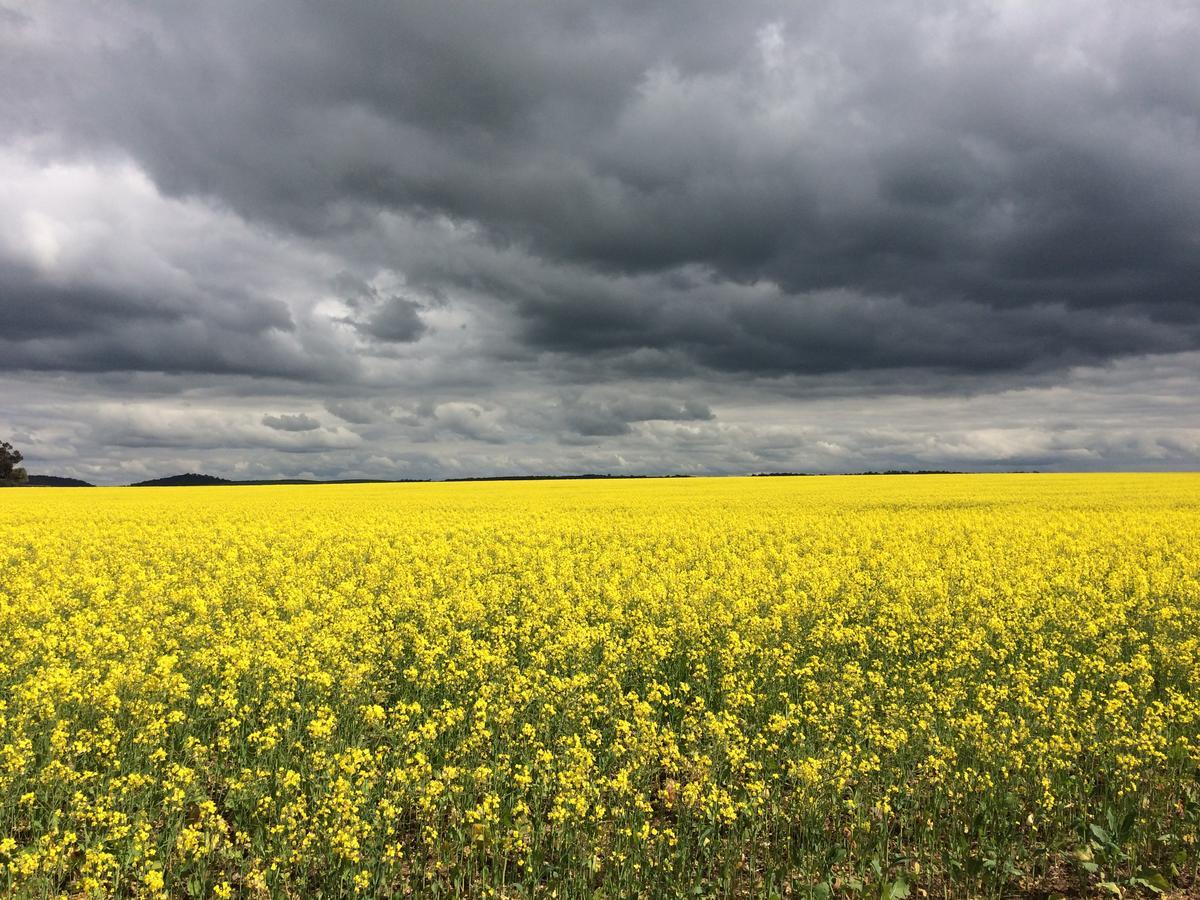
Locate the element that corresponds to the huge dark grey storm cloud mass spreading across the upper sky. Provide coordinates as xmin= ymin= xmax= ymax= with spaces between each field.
xmin=5 ymin=1 xmax=1200 ymax=371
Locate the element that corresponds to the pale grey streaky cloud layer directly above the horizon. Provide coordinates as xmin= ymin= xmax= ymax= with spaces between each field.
xmin=0 ymin=354 xmax=1200 ymax=484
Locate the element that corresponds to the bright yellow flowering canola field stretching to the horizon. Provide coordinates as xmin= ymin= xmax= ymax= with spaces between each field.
xmin=0 ymin=474 xmax=1200 ymax=900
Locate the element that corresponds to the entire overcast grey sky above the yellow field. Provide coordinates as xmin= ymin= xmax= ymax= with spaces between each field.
xmin=0 ymin=0 xmax=1200 ymax=484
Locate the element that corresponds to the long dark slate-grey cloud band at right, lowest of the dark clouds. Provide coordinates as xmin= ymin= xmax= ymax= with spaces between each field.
xmin=448 ymin=256 xmax=1200 ymax=376
